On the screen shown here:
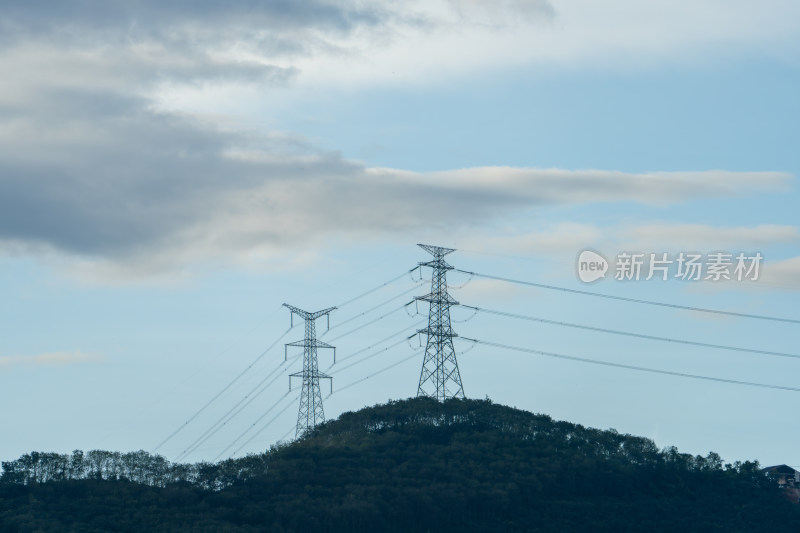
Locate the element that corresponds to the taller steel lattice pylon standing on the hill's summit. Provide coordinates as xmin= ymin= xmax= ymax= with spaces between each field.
xmin=416 ymin=244 xmax=465 ymax=401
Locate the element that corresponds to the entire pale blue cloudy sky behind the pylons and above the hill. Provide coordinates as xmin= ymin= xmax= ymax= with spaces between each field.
xmin=0 ymin=0 xmax=800 ymax=465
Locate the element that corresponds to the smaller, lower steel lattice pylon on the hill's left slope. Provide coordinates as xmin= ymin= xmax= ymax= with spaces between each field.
xmin=283 ymin=304 xmax=336 ymax=437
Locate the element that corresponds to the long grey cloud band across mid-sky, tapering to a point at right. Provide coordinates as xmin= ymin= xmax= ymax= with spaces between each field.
xmin=0 ymin=144 xmax=789 ymax=270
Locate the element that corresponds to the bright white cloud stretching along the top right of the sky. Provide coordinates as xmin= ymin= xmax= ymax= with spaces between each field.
xmin=270 ymin=0 xmax=800 ymax=87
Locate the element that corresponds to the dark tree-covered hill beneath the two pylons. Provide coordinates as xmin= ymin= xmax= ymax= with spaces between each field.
xmin=0 ymin=398 xmax=800 ymax=532
